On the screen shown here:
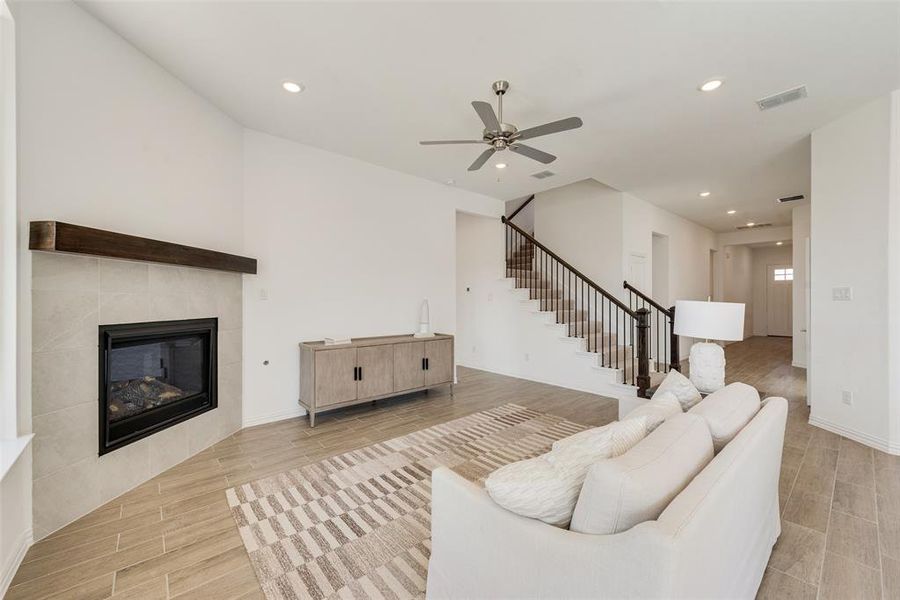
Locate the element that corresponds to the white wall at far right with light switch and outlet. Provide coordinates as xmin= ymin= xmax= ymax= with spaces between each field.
xmin=809 ymin=92 xmax=900 ymax=453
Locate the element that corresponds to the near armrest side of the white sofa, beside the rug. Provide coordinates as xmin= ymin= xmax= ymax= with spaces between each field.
xmin=428 ymin=467 xmax=672 ymax=598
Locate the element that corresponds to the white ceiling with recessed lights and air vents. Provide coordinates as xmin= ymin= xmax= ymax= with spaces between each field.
xmin=79 ymin=0 xmax=900 ymax=231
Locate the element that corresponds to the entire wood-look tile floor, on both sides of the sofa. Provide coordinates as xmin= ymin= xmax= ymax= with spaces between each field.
xmin=6 ymin=338 xmax=900 ymax=600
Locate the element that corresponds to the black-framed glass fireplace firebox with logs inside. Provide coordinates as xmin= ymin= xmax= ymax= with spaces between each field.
xmin=99 ymin=319 xmax=218 ymax=455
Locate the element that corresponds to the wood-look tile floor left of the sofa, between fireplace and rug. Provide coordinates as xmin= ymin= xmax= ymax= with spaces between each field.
xmin=6 ymin=367 xmax=618 ymax=600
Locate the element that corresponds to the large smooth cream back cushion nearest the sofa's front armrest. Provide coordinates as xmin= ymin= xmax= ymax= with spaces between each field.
xmin=569 ymin=414 xmax=713 ymax=534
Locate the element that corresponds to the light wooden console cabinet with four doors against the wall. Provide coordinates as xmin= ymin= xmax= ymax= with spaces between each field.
xmin=300 ymin=333 xmax=453 ymax=427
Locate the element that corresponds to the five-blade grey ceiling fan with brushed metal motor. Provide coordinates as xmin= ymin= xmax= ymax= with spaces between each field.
xmin=419 ymin=80 xmax=582 ymax=171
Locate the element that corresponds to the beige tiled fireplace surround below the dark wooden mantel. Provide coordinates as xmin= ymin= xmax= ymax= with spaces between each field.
xmin=32 ymin=252 xmax=242 ymax=539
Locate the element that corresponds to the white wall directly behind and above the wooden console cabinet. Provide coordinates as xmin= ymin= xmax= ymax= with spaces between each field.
xmin=244 ymin=131 xmax=504 ymax=425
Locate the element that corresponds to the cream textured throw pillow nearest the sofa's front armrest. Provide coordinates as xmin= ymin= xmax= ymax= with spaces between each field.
xmin=484 ymin=419 xmax=646 ymax=527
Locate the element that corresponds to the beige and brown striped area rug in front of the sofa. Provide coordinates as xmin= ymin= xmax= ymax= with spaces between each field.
xmin=226 ymin=404 xmax=584 ymax=600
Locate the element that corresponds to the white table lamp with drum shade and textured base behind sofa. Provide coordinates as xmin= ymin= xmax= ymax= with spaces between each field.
xmin=675 ymin=300 xmax=744 ymax=394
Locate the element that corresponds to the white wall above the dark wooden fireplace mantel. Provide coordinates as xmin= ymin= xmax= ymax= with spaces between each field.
xmin=13 ymin=2 xmax=250 ymax=535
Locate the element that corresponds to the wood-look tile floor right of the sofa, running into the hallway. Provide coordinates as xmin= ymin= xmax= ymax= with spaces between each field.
xmin=725 ymin=337 xmax=900 ymax=600
